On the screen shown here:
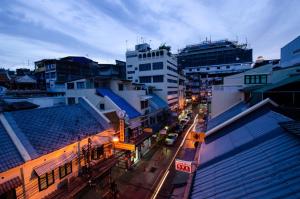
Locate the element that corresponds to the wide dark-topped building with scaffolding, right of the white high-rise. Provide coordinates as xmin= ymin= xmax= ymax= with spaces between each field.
xmin=177 ymin=40 xmax=252 ymax=100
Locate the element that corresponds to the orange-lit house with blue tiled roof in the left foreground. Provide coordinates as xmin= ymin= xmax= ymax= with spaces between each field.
xmin=0 ymin=99 xmax=116 ymax=199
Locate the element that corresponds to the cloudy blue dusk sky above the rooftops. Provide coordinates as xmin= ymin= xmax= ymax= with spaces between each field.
xmin=0 ymin=0 xmax=300 ymax=69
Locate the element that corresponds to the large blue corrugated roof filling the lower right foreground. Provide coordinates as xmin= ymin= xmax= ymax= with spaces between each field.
xmin=190 ymin=110 xmax=300 ymax=199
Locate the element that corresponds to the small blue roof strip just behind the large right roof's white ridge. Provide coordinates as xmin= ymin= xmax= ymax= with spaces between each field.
xmin=207 ymin=102 xmax=248 ymax=130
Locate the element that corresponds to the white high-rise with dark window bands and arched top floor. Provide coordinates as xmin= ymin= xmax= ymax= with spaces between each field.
xmin=126 ymin=43 xmax=185 ymax=111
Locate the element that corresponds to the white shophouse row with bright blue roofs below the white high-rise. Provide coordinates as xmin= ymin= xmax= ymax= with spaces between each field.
xmin=66 ymin=77 xmax=168 ymax=166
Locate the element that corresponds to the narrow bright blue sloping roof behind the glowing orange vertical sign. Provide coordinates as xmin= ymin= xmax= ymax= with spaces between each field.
xmin=97 ymin=88 xmax=141 ymax=119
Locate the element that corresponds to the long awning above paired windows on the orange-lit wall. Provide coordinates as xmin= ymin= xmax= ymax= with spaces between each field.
xmin=33 ymin=152 xmax=77 ymax=176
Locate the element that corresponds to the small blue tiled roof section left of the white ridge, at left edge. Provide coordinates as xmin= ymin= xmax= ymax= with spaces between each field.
xmin=0 ymin=124 xmax=24 ymax=173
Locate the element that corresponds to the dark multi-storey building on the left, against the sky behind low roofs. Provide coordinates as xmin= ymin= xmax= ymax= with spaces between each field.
xmin=35 ymin=56 xmax=99 ymax=95
